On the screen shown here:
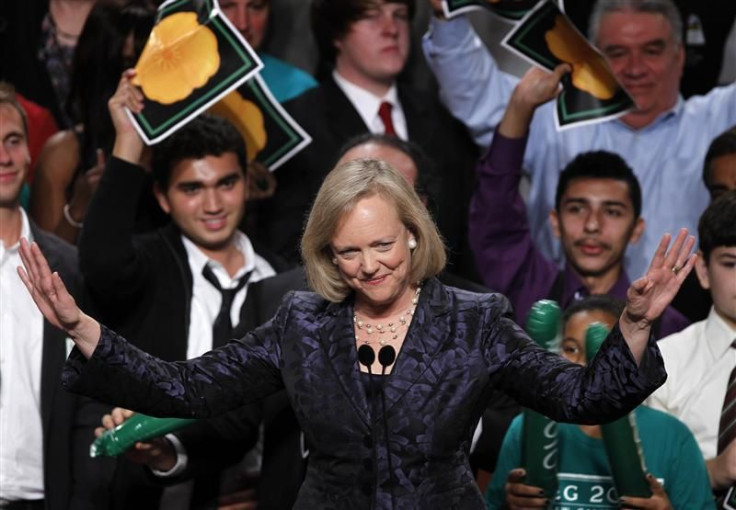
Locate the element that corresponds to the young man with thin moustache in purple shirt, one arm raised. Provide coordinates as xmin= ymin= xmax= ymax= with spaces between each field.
xmin=470 ymin=65 xmax=688 ymax=334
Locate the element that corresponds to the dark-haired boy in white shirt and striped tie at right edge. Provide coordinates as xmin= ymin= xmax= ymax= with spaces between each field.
xmin=647 ymin=190 xmax=736 ymax=500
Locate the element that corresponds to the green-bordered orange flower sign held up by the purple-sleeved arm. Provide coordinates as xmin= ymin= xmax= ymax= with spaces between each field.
xmin=502 ymin=0 xmax=635 ymax=129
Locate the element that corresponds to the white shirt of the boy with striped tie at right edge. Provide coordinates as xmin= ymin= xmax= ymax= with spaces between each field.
xmin=646 ymin=308 xmax=736 ymax=460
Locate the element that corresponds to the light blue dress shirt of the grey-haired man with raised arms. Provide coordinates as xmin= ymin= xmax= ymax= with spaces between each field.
xmin=423 ymin=16 xmax=736 ymax=278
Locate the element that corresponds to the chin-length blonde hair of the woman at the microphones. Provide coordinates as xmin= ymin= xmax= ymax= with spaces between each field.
xmin=301 ymin=159 xmax=447 ymax=302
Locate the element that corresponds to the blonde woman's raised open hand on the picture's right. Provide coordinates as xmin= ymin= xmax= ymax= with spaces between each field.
xmin=621 ymin=228 xmax=697 ymax=329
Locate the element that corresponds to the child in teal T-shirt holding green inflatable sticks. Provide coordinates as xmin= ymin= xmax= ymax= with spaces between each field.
xmin=486 ymin=295 xmax=713 ymax=510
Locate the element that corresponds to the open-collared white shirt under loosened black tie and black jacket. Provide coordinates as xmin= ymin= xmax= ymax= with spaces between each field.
xmin=182 ymin=231 xmax=276 ymax=359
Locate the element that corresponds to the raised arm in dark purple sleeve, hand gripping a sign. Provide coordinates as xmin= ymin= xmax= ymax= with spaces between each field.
xmin=469 ymin=65 xmax=569 ymax=314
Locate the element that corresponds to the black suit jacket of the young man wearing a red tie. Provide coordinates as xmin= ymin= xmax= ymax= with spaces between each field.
xmin=256 ymin=77 xmax=480 ymax=281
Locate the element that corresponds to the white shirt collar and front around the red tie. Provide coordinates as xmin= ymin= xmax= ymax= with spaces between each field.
xmin=332 ymin=71 xmax=409 ymax=140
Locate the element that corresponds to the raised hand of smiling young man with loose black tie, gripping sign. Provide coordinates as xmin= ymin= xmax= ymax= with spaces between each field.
xmin=107 ymin=69 xmax=143 ymax=165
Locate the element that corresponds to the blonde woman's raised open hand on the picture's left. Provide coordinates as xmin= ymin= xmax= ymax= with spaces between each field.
xmin=18 ymin=238 xmax=101 ymax=358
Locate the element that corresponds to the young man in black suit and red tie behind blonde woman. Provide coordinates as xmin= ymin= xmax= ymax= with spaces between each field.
xmin=258 ymin=0 xmax=478 ymax=278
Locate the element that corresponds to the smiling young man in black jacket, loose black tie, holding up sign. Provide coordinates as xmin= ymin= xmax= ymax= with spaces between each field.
xmin=79 ymin=71 xmax=285 ymax=510
